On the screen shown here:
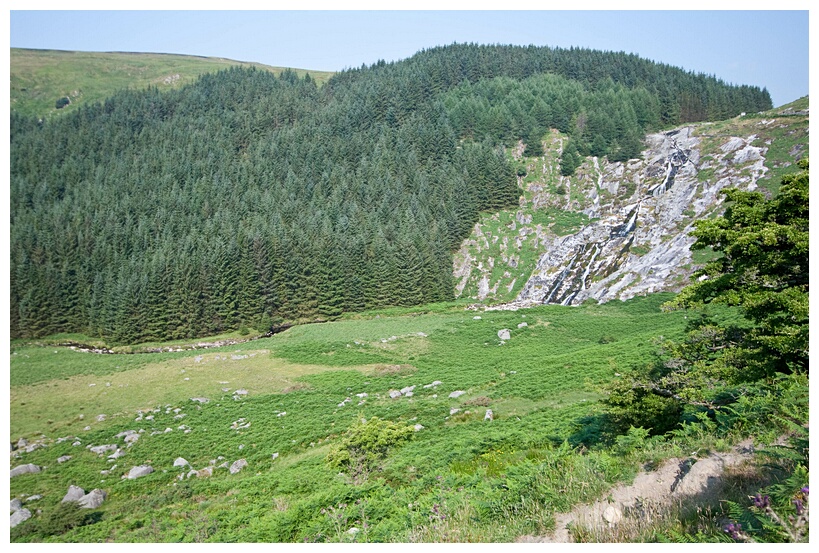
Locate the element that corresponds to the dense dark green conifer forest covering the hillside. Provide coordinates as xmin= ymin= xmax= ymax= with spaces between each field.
xmin=11 ymin=45 xmax=770 ymax=342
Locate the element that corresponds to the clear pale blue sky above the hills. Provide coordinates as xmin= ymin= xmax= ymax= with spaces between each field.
xmin=10 ymin=7 xmax=809 ymax=106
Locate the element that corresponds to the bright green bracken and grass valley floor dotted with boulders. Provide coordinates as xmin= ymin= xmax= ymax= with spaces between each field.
xmin=10 ymin=294 xmax=696 ymax=542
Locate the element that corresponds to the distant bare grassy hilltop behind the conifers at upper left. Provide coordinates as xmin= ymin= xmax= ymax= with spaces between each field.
xmin=10 ymin=48 xmax=332 ymax=118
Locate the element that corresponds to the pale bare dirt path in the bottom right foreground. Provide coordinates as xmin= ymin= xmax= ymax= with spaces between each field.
xmin=517 ymin=440 xmax=754 ymax=543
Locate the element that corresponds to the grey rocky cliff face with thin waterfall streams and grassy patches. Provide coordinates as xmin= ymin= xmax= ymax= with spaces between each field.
xmin=455 ymin=109 xmax=807 ymax=309
